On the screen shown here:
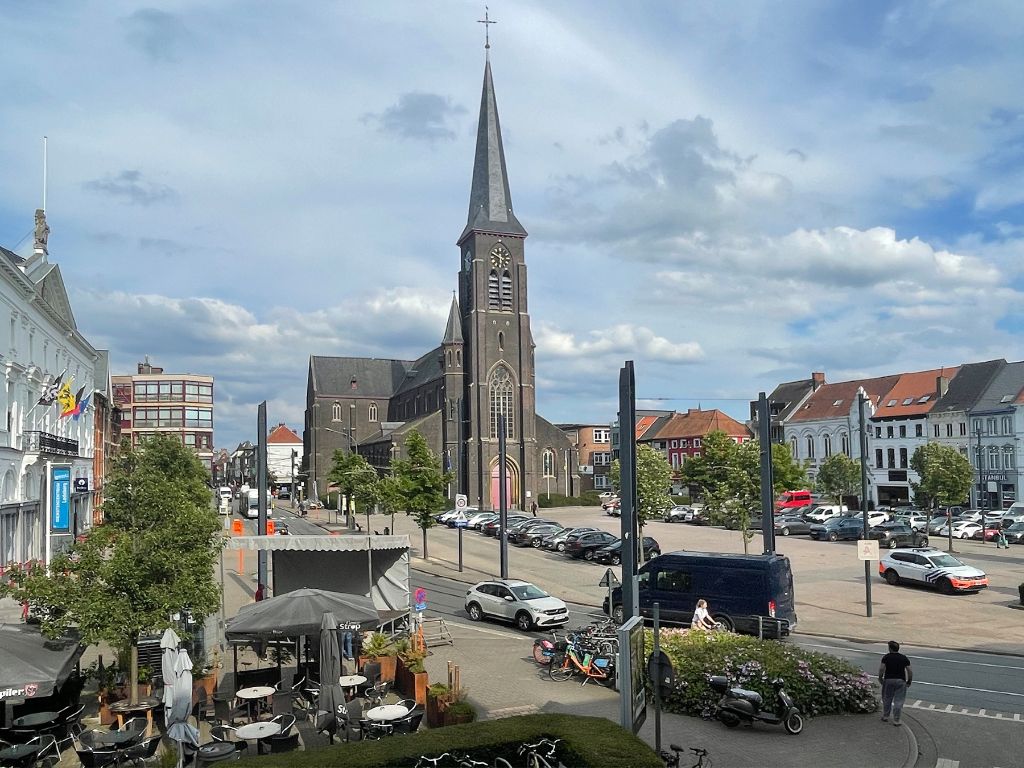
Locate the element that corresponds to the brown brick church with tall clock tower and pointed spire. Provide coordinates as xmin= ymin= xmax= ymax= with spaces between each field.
xmin=303 ymin=55 xmax=579 ymax=509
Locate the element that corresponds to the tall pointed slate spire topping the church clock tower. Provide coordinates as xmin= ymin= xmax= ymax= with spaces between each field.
xmin=459 ymin=60 xmax=526 ymax=242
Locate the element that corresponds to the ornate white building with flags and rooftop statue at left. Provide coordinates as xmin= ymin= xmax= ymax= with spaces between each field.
xmin=0 ymin=211 xmax=102 ymax=570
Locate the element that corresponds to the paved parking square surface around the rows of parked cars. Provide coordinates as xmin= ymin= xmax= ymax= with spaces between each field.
xmin=385 ymin=507 xmax=1024 ymax=653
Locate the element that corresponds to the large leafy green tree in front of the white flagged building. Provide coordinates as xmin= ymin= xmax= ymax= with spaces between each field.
xmin=0 ymin=435 xmax=223 ymax=702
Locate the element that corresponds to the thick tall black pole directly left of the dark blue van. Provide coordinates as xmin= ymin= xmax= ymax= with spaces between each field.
xmin=608 ymin=360 xmax=640 ymax=622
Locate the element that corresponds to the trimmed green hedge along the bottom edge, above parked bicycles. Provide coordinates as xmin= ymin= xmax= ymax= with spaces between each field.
xmin=236 ymin=715 xmax=665 ymax=768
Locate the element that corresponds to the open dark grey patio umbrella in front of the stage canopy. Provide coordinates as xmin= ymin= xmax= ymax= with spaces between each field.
xmin=224 ymin=589 xmax=381 ymax=642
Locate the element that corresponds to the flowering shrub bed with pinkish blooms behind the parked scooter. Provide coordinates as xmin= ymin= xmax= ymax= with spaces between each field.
xmin=647 ymin=630 xmax=879 ymax=717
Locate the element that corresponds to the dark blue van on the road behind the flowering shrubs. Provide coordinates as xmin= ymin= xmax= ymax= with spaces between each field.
xmin=603 ymin=552 xmax=797 ymax=638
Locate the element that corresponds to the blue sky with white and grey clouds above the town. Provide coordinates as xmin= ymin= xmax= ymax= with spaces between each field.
xmin=0 ymin=0 xmax=1024 ymax=447
